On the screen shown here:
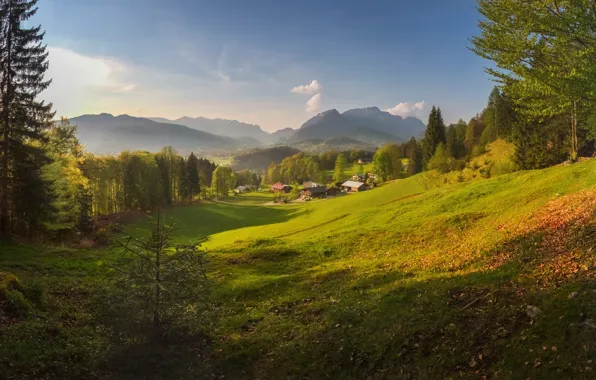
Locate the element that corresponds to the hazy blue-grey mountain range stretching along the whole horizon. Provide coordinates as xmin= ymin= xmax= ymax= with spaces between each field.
xmin=71 ymin=107 xmax=425 ymax=154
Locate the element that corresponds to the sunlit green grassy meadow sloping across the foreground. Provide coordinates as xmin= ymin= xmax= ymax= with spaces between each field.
xmin=0 ymin=160 xmax=596 ymax=379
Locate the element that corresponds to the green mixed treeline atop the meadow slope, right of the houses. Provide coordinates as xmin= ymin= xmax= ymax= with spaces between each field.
xmin=374 ymin=81 xmax=556 ymax=180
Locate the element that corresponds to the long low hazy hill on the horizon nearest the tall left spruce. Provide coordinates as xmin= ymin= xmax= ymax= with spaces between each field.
xmin=70 ymin=113 xmax=244 ymax=154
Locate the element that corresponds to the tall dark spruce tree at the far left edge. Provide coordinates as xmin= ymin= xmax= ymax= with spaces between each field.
xmin=0 ymin=0 xmax=54 ymax=235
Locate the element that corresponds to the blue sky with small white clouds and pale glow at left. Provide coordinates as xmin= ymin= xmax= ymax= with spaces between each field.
xmin=36 ymin=0 xmax=494 ymax=131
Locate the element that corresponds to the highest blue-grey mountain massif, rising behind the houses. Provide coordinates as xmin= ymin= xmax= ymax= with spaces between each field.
xmin=290 ymin=107 xmax=425 ymax=145
